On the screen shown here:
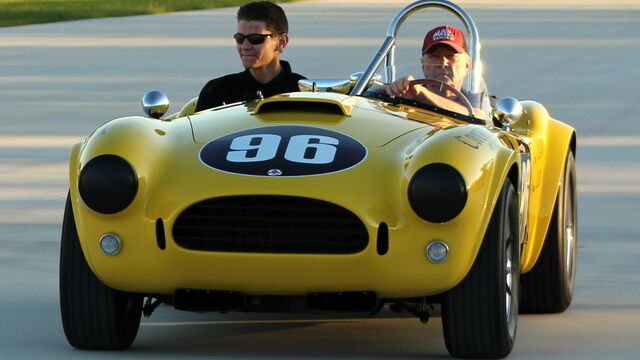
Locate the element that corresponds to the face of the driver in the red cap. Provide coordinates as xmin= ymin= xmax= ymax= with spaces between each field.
xmin=422 ymin=44 xmax=471 ymax=90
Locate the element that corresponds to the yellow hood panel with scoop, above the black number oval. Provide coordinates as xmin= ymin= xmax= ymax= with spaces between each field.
xmin=190 ymin=92 xmax=438 ymax=147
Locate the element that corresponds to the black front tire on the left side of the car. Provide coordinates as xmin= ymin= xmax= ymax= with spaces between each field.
xmin=60 ymin=196 xmax=142 ymax=350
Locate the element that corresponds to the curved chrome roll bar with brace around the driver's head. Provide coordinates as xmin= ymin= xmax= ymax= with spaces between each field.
xmin=351 ymin=0 xmax=482 ymax=95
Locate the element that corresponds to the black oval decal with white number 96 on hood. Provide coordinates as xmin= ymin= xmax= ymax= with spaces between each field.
xmin=200 ymin=126 xmax=367 ymax=176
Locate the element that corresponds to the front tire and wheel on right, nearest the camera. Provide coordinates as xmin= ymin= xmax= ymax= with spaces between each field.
xmin=442 ymin=179 xmax=520 ymax=359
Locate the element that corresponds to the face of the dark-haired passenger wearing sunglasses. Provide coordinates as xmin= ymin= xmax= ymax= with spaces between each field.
xmin=236 ymin=20 xmax=281 ymax=69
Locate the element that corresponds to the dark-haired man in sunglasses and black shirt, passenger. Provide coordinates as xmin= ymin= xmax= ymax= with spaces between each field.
xmin=195 ymin=1 xmax=305 ymax=112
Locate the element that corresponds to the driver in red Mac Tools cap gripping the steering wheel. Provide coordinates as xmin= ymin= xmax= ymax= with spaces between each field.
xmin=387 ymin=26 xmax=484 ymax=117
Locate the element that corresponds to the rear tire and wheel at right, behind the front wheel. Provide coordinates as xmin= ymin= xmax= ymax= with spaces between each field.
xmin=520 ymin=151 xmax=578 ymax=314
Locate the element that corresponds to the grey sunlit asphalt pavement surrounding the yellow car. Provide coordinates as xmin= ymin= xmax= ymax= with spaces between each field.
xmin=0 ymin=0 xmax=640 ymax=359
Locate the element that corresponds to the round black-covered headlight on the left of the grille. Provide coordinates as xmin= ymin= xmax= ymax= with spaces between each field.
xmin=78 ymin=155 xmax=138 ymax=214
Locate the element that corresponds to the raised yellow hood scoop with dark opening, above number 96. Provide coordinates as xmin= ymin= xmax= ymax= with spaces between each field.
xmin=253 ymin=93 xmax=357 ymax=116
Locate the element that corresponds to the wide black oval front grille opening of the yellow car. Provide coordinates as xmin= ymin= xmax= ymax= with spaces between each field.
xmin=173 ymin=196 xmax=369 ymax=254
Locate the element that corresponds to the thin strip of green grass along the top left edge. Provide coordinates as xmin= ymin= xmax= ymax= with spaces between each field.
xmin=0 ymin=0 xmax=293 ymax=27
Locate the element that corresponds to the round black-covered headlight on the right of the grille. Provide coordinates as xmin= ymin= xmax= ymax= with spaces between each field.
xmin=408 ymin=163 xmax=467 ymax=223
